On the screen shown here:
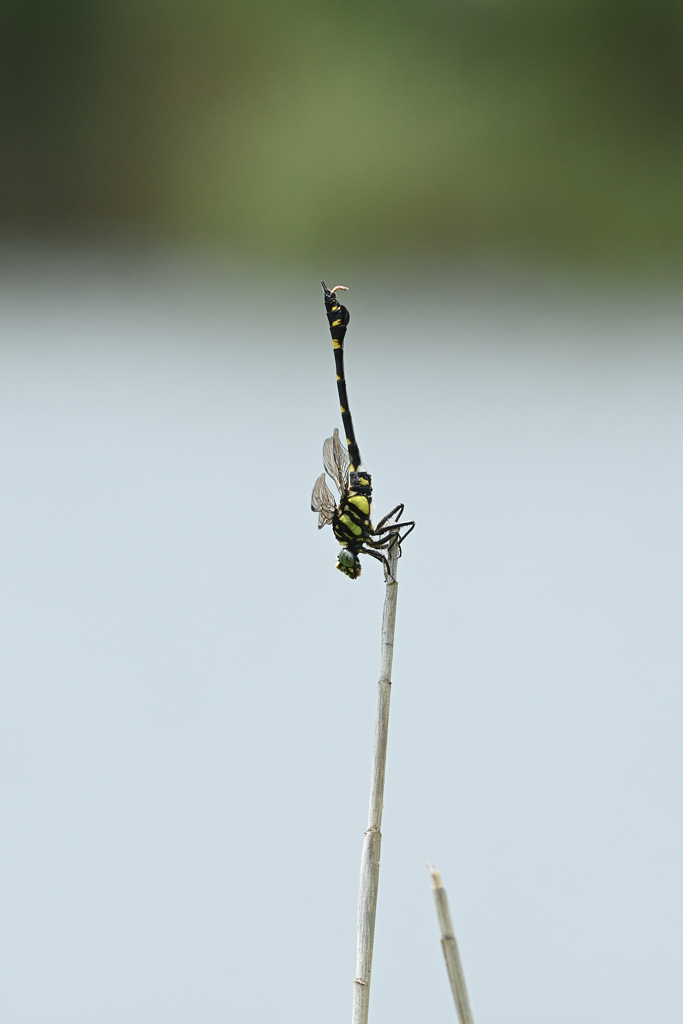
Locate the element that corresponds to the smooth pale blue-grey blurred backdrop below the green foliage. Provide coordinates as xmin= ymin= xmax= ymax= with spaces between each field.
xmin=0 ymin=249 xmax=683 ymax=1024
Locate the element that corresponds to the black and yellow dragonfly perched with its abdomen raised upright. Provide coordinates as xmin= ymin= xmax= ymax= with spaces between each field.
xmin=310 ymin=281 xmax=415 ymax=581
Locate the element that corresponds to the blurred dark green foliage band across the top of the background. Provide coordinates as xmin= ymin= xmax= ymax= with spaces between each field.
xmin=0 ymin=0 xmax=683 ymax=262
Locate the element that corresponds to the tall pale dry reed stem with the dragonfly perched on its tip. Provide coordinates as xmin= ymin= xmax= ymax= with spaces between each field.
xmin=352 ymin=544 xmax=398 ymax=1024
